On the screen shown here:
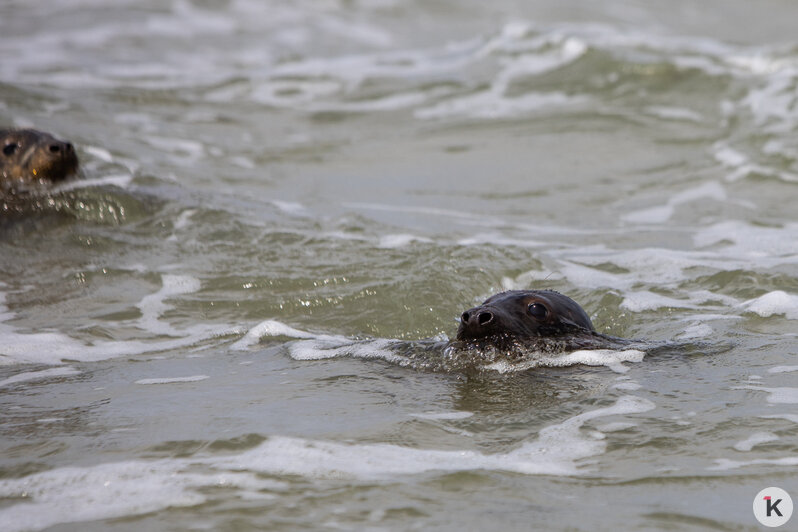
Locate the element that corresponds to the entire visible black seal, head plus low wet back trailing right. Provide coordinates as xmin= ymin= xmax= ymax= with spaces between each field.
xmin=457 ymin=290 xmax=629 ymax=352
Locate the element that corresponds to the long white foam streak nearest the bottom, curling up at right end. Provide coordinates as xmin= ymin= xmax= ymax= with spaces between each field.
xmin=0 ymin=396 xmax=655 ymax=532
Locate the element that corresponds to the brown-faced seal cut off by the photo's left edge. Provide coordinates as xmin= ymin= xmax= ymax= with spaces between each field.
xmin=0 ymin=129 xmax=78 ymax=192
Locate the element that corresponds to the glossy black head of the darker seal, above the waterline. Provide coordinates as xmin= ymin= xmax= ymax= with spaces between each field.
xmin=457 ymin=290 xmax=595 ymax=342
